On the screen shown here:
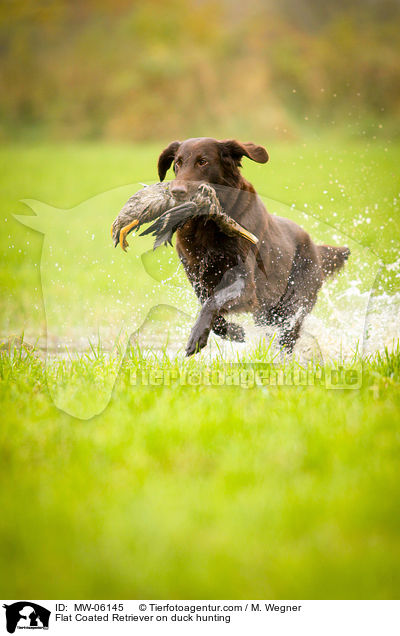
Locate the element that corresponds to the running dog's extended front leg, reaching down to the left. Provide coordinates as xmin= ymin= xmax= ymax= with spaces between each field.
xmin=186 ymin=265 xmax=246 ymax=356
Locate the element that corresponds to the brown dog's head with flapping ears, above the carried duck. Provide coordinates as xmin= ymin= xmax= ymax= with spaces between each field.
xmin=158 ymin=137 xmax=268 ymax=199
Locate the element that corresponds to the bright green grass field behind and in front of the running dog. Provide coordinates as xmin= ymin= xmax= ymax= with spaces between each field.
xmin=0 ymin=138 xmax=400 ymax=599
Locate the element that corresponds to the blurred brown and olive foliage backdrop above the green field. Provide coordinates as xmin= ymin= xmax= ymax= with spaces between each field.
xmin=0 ymin=0 xmax=400 ymax=141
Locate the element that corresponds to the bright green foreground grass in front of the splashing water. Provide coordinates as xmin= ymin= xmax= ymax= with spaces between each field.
xmin=0 ymin=340 xmax=400 ymax=598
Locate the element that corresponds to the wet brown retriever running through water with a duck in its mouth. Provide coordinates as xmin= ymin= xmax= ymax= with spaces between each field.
xmin=158 ymin=138 xmax=350 ymax=355
